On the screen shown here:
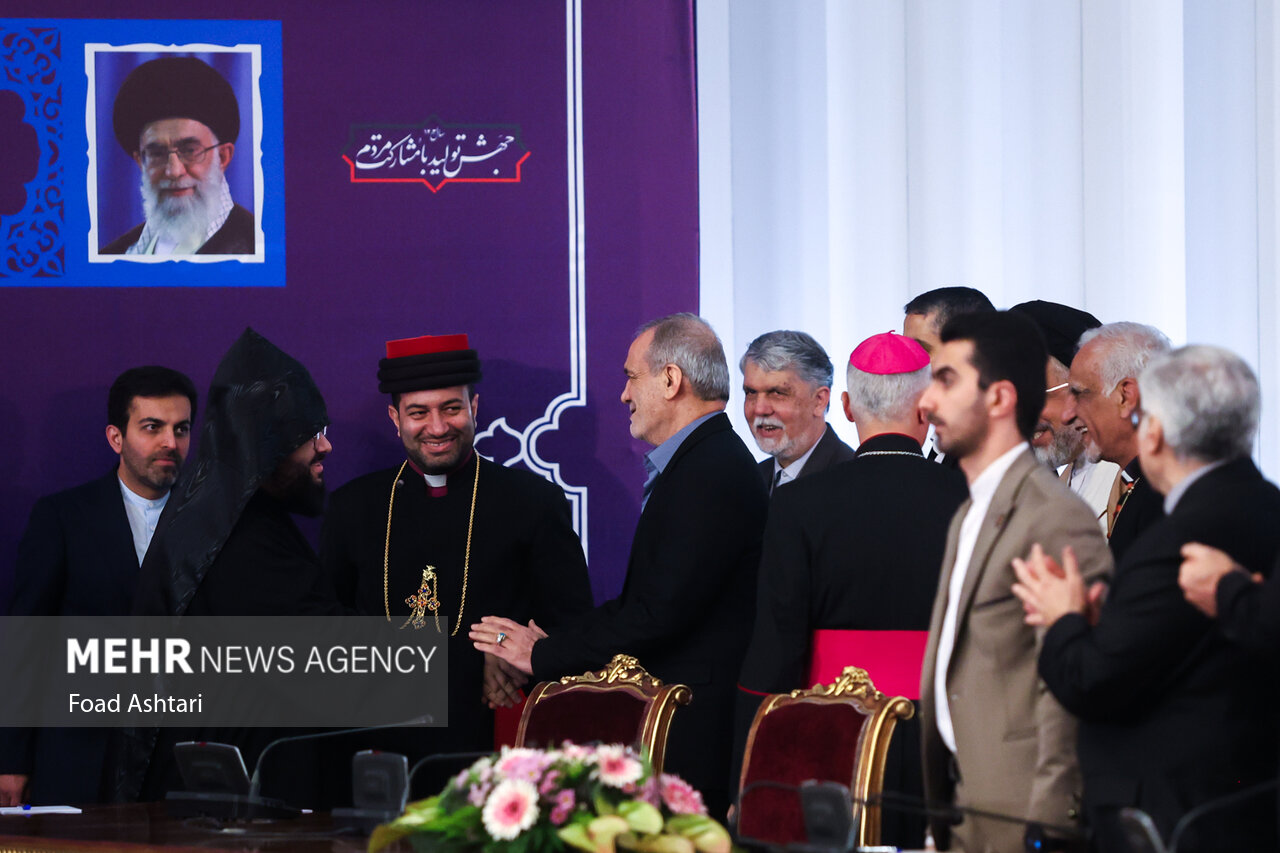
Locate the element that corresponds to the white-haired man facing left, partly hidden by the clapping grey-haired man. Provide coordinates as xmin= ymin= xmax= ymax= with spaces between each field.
xmin=1062 ymin=323 xmax=1169 ymax=564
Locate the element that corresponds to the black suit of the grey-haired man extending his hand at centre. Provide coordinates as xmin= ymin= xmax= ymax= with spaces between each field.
xmin=532 ymin=412 xmax=768 ymax=813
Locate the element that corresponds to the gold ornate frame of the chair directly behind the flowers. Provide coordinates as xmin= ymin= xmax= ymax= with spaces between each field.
xmin=516 ymin=654 xmax=694 ymax=772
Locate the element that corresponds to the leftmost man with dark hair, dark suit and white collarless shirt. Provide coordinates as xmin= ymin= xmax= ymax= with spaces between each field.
xmin=0 ymin=366 xmax=196 ymax=806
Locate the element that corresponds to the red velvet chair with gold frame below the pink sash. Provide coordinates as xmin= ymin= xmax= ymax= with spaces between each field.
xmin=737 ymin=666 xmax=915 ymax=845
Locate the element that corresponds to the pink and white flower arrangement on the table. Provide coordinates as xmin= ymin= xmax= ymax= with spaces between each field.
xmin=369 ymin=742 xmax=732 ymax=853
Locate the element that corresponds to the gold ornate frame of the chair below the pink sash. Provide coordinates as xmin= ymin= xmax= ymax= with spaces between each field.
xmin=739 ymin=666 xmax=915 ymax=847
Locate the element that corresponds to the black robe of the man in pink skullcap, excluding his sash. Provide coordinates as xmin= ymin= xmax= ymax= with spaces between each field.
xmin=730 ymin=434 xmax=969 ymax=848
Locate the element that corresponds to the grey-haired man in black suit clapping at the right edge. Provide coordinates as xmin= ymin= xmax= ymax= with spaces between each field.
xmin=1015 ymin=346 xmax=1280 ymax=850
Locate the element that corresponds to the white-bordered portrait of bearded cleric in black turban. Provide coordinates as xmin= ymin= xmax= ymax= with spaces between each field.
xmin=84 ymin=45 xmax=264 ymax=263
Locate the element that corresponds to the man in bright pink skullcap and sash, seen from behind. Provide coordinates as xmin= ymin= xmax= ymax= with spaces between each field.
xmin=735 ymin=332 xmax=969 ymax=848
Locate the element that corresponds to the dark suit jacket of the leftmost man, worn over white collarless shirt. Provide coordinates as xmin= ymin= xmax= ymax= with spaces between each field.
xmin=0 ymin=469 xmax=138 ymax=804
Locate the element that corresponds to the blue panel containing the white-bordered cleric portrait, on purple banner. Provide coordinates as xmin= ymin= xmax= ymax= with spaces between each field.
xmin=0 ymin=19 xmax=285 ymax=287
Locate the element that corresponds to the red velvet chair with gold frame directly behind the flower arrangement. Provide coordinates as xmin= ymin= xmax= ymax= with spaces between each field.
xmin=516 ymin=654 xmax=692 ymax=772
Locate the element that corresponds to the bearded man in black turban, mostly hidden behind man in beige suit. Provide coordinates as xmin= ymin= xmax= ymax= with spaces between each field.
xmin=1010 ymin=300 xmax=1120 ymax=533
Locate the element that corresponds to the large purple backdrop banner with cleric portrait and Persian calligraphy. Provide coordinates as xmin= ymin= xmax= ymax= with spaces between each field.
xmin=0 ymin=0 xmax=698 ymax=616
